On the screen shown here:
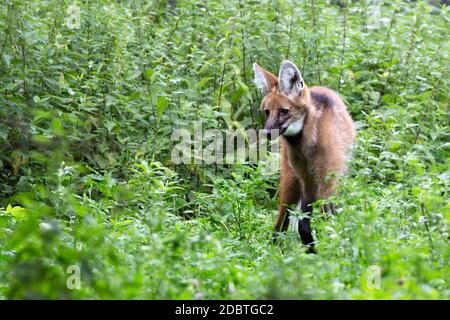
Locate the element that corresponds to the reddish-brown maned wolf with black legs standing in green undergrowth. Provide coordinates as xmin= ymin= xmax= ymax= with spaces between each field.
xmin=253 ymin=61 xmax=355 ymax=252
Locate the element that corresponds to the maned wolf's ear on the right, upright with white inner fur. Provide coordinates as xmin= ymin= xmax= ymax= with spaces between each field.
xmin=278 ymin=60 xmax=305 ymax=99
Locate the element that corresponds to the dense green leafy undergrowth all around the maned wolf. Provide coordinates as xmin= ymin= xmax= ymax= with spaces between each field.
xmin=0 ymin=0 xmax=450 ymax=299
